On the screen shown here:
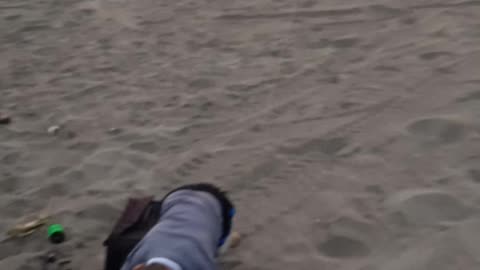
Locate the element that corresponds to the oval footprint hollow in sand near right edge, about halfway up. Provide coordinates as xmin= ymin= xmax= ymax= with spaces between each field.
xmin=407 ymin=117 xmax=467 ymax=144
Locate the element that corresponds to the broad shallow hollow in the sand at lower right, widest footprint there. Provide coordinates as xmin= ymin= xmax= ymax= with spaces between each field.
xmin=386 ymin=189 xmax=472 ymax=226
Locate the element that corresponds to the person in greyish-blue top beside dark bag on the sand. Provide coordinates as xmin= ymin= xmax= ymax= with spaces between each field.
xmin=121 ymin=184 xmax=235 ymax=270
